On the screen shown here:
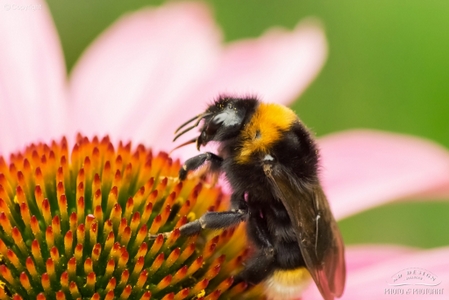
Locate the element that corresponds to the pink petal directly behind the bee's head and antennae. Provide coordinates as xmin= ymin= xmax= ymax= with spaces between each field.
xmin=157 ymin=20 xmax=327 ymax=154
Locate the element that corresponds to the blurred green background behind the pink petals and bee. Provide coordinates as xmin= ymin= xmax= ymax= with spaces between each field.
xmin=48 ymin=0 xmax=449 ymax=248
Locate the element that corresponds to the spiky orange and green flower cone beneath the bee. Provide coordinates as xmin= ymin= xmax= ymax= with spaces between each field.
xmin=0 ymin=135 xmax=261 ymax=300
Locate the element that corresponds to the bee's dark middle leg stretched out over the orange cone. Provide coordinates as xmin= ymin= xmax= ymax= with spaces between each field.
xmin=179 ymin=209 xmax=247 ymax=236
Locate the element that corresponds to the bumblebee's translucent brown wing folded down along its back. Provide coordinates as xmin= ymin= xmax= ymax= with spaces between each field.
xmin=264 ymin=163 xmax=346 ymax=300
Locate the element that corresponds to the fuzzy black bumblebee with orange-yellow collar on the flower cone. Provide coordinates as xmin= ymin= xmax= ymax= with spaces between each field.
xmin=170 ymin=96 xmax=346 ymax=300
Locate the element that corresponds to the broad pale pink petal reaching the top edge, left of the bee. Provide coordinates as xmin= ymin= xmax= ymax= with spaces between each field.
xmin=70 ymin=3 xmax=221 ymax=147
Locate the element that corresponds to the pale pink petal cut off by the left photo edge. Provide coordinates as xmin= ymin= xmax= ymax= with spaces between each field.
xmin=0 ymin=0 xmax=66 ymax=154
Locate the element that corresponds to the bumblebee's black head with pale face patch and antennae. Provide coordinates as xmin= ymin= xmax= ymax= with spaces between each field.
xmin=173 ymin=97 xmax=258 ymax=150
